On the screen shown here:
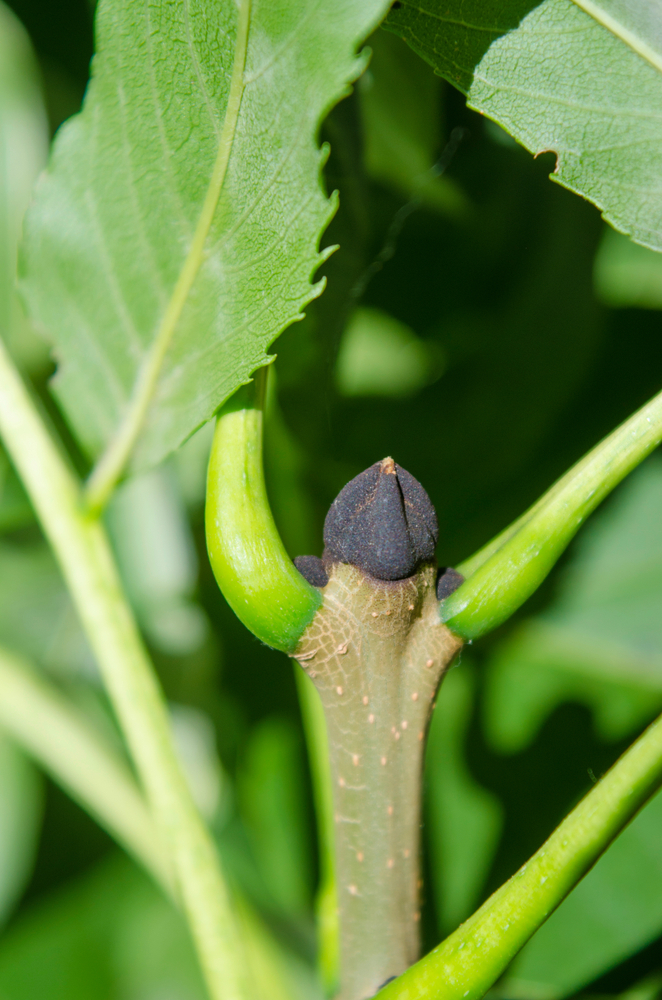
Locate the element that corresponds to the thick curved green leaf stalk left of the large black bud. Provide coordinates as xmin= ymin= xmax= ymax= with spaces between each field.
xmin=205 ymin=369 xmax=322 ymax=653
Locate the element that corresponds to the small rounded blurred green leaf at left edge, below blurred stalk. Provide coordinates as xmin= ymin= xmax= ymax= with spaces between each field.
xmin=0 ymin=734 xmax=42 ymax=924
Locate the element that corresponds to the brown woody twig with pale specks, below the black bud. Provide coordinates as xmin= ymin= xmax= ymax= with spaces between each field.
xmin=295 ymin=563 xmax=462 ymax=1000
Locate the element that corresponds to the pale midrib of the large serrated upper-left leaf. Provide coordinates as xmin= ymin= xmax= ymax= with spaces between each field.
xmin=86 ymin=0 xmax=251 ymax=511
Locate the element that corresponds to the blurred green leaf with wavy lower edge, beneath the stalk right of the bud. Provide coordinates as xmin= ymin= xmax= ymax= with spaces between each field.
xmin=486 ymin=456 xmax=662 ymax=752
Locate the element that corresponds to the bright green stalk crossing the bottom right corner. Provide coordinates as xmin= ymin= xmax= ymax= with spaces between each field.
xmin=379 ymin=704 xmax=662 ymax=1000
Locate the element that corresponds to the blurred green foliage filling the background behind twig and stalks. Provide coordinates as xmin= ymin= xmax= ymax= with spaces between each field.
xmin=0 ymin=0 xmax=662 ymax=1000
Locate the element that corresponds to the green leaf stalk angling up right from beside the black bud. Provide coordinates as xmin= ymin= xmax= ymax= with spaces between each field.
xmin=440 ymin=384 xmax=662 ymax=639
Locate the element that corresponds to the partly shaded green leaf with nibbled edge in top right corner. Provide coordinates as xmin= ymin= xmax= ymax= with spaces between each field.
xmin=386 ymin=0 xmax=662 ymax=250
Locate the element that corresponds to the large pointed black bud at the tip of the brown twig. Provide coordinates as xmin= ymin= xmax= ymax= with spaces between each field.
xmin=324 ymin=458 xmax=439 ymax=580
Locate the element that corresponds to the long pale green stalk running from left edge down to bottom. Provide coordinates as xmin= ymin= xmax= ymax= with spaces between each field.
xmin=0 ymin=342 xmax=246 ymax=1000
